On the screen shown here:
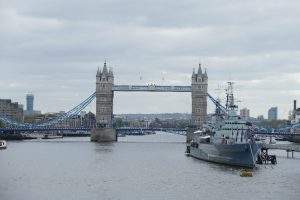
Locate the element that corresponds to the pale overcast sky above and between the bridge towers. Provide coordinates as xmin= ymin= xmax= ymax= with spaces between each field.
xmin=0 ymin=0 xmax=300 ymax=118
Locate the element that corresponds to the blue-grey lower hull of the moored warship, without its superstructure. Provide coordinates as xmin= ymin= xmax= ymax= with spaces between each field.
xmin=190 ymin=143 xmax=261 ymax=168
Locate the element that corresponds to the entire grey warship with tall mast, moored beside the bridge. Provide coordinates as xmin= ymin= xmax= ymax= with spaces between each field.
xmin=187 ymin=82 xmax=262 ymax=168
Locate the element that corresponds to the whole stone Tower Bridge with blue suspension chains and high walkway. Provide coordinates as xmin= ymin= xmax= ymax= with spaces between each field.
xmin=0 ymin=63 xmax=300 ymax=141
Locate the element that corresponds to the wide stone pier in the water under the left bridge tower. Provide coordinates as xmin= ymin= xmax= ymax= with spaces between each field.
xmin=91 ymin=128 xmax=118 ymax=142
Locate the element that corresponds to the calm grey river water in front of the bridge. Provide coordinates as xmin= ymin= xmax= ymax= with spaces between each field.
xmin=0 ymin=133 xmax=300 ymax=200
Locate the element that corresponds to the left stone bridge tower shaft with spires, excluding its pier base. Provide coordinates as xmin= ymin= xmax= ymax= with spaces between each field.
xmin=96 ymin=62 xmax=114 ymax=128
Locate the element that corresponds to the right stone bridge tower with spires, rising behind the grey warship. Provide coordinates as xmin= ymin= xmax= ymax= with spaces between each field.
xmin=192 ymin=64 xmax=208 ymax=128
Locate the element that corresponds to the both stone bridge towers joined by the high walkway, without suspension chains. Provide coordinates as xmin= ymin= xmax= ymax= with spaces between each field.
xmin=91 ymin=62 xmax=208 ymax=141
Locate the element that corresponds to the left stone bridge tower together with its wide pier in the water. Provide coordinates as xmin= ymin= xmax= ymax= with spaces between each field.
xmin=91 ymin=62 xmax=117 ymax=142
